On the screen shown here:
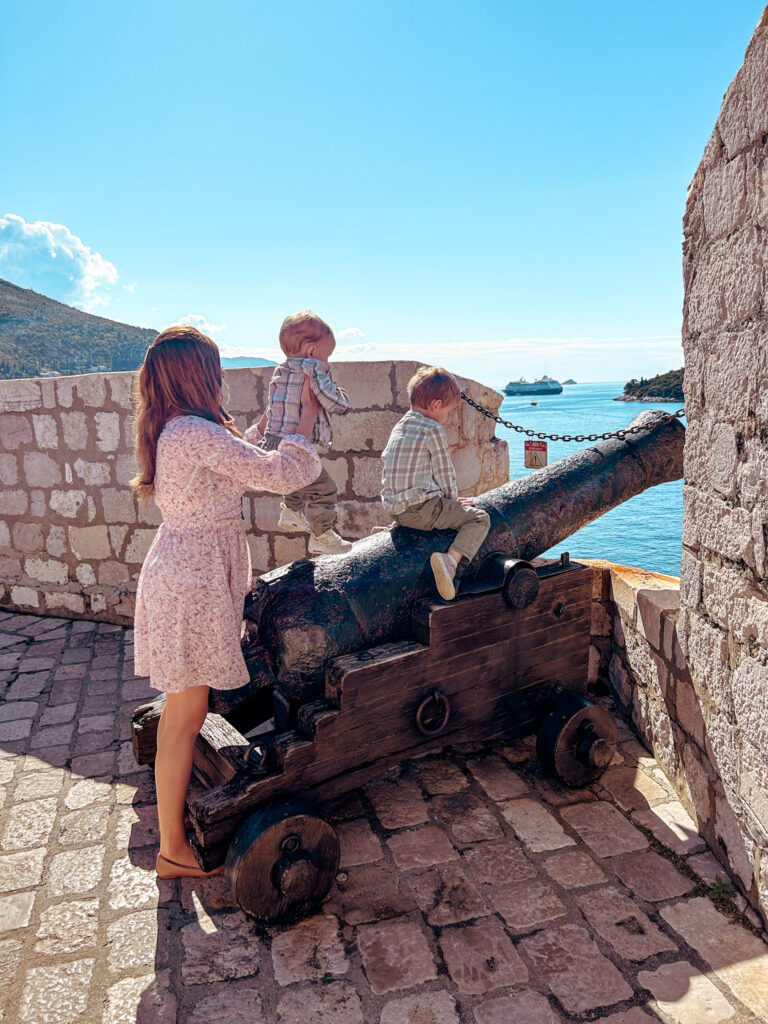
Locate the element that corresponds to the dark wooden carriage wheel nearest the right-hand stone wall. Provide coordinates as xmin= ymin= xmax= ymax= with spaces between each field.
xmin=536 ymin=693 xmax=618 ymax=786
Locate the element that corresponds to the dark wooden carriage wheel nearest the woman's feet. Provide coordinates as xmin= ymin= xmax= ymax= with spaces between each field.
xmin=225 ymin=804 xmax=339 ymax=924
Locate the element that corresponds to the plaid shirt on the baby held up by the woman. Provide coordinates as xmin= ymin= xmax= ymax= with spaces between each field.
xmin=265 ymin=356 xmax=349 ymax=446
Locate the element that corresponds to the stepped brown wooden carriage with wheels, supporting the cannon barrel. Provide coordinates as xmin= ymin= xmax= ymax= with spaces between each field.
xmin=134 ymin=556 xmax=616 ymax=921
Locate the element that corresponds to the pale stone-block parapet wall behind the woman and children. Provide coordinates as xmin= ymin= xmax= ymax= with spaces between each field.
xmin=0 ymin=362 xmax=509 ymax=623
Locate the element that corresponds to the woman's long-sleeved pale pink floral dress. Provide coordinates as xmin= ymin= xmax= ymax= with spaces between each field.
xmin=134 ymin=416 xmax=321 ymax=693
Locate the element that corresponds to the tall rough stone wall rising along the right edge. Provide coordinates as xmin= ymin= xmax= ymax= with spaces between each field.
xmin=679 ymin=8 xmax=768 ymax=929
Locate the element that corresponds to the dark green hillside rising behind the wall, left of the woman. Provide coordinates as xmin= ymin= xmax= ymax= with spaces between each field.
xmin=0 ymin=279 xmax=158 ymax=379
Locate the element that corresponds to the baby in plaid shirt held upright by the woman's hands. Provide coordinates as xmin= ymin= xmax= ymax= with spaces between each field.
xmin=259 ymin=310 xmax=352 ymax=555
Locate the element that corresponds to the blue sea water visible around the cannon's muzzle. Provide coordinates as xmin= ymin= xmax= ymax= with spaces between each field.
xmin=496 ymin=382 xmax=685 ymax=577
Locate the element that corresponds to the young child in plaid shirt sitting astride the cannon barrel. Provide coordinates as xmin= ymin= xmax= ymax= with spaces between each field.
xmin=381 ymin=367 xmax=490 ymax=601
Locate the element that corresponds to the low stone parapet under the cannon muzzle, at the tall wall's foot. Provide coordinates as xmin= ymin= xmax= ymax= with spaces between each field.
xmin=590 ymin=561 xmax=768 ymax=925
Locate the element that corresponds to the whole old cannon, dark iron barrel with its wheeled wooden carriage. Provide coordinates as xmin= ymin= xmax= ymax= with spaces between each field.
xmin=133 ymin=412 xmax=685 ymax=922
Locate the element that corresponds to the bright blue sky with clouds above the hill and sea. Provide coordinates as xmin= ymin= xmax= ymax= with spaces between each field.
xmin=0 ymin=0 xmax=763 ymax=385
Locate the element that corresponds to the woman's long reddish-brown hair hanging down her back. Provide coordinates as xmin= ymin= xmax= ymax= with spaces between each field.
xmin=131 ymin=326 xmax=243 ymax=501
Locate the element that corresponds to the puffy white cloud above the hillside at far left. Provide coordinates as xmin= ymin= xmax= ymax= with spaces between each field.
xmin=0 ymin=213 xmax=118 ymax=312
